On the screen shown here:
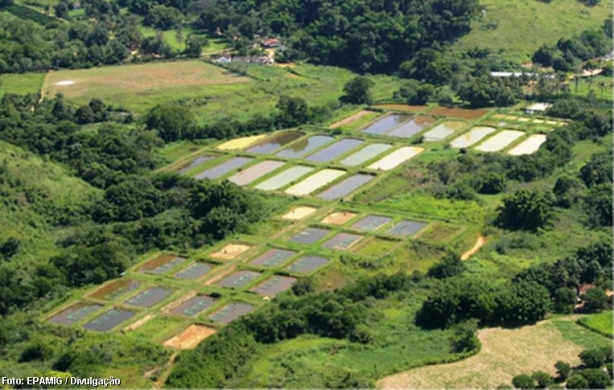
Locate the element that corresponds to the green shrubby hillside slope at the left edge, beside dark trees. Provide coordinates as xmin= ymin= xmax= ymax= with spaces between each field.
xmin=0 ymin=141 xmax=99 ymax=263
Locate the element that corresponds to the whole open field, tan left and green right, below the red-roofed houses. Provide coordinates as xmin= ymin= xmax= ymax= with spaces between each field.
xmin=43 ymin=61 xmax=397 ymax=122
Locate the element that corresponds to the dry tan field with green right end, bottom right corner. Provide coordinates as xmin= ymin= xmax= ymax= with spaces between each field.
xmin=378 ymin=318 xmax=608 ymax=388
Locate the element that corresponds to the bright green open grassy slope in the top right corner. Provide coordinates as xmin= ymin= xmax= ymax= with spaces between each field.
xmin=455 ymin=0 xmax=612 ymax=62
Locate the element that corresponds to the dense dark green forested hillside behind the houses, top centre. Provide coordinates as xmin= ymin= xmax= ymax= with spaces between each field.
xmin=196 ymin=0 xmax=479 ymax=73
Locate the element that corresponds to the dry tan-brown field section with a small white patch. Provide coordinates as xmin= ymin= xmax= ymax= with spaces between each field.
xmin=43 ymin=61 xmax=251 ymax=113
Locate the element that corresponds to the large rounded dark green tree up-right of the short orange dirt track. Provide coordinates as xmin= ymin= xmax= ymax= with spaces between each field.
xmin=496 ymin=190 xmax=554 ymax=232
